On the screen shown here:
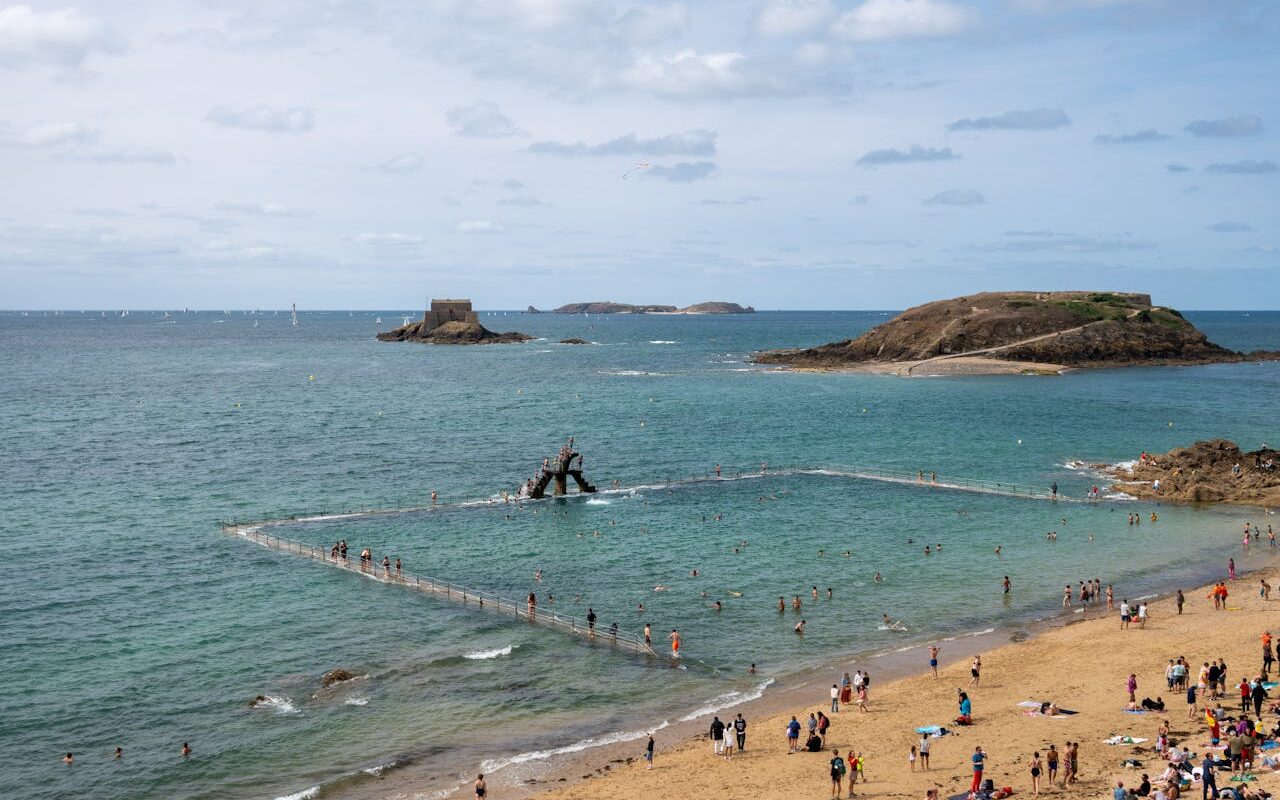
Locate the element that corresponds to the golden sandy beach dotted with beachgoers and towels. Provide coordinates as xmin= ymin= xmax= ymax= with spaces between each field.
xmin=536 ymin=558 xmax=1280 ymax=800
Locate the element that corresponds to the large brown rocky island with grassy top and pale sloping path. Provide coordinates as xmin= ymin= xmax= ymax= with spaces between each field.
xmin=755 ymin=292 xmax=1280 ymax=375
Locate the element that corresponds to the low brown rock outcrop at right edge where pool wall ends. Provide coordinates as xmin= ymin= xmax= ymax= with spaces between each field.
xmin=1108 ymin=439 xmax=1280 ymax=506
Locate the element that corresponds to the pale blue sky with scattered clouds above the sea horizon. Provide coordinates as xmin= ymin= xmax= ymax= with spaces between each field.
xmin=0 ymin=0 xmax=1280 ymax=310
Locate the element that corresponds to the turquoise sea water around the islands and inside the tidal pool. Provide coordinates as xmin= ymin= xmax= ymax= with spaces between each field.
xmin=0 ymin=312 xmax=1280 ymax=799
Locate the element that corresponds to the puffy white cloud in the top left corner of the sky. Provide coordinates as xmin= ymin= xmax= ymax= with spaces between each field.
xmin=0 ymin=5 xmax=120 ymax=67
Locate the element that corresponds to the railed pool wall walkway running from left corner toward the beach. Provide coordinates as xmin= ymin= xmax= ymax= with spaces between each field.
xmin=223 ymin=525 xmax=669 ymax=658
